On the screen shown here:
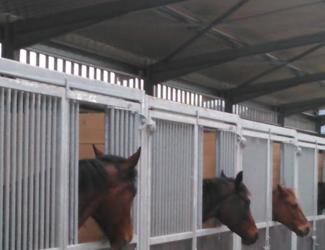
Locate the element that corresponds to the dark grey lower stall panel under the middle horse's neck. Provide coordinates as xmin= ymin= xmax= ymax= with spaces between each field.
xmin=197 ymin=232 xmax=233 ymax=250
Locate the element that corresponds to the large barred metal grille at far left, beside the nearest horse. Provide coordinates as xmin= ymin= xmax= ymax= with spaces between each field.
xmin=0 ymin=88 xmax=61 ymax=250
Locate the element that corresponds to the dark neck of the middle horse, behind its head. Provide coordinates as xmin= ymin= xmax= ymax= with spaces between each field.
xmin=203 ymin=178 xmax=233 ymax=221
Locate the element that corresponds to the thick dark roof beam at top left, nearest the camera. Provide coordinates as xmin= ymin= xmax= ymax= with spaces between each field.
xmin=11 ymin=0 xmax=187 ymax=49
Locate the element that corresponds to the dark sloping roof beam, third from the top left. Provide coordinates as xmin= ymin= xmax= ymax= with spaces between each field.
xmin=228 ymin=72 xmax=325 ymax=104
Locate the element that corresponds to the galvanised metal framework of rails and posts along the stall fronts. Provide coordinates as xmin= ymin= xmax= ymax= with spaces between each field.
xmin=0 ymin=59 xmax=325 ymax=250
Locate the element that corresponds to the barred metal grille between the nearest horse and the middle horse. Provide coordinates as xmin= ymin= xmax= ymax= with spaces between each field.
xmin=151 ymin=120 xmax=194 ymax=237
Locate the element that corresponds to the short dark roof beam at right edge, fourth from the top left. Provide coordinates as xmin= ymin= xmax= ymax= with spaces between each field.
xmin=279 ymin=97 xmax=325 ymax=117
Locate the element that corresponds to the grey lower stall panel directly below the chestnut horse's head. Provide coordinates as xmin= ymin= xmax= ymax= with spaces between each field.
xmin=270 ymin=225 xmax=291 ymax=250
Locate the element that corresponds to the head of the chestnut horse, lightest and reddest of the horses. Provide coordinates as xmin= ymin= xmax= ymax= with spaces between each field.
xmin=272 ymin=184 xmax=311 ymax=237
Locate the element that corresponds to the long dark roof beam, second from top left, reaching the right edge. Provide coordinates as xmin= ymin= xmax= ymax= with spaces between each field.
xmin=151 ymin=31 xmax=325 ymax=83
